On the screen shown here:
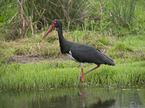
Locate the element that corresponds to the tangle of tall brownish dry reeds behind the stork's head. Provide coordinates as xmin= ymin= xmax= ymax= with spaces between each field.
xmin=2 ymin=0 xmax=87 ymax=39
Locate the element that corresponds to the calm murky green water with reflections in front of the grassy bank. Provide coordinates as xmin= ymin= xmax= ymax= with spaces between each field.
xmin=0 ymin=88 xmax=145 ymax=108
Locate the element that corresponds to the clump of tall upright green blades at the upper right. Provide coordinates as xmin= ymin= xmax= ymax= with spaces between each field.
xmin=110 ymin=0 xmax=136 ymax=27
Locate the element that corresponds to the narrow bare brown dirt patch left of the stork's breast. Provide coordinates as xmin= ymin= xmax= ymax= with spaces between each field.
xmin=7 ymin=55 xmax=69 ymax=64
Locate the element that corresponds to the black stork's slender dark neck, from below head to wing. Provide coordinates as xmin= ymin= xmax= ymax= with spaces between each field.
xmin=57 ymin=25 xmax=71 ymax=53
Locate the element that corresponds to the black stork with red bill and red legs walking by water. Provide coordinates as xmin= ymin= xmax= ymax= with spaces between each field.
xmin=41 ymin=19 xmax=115 ymax=83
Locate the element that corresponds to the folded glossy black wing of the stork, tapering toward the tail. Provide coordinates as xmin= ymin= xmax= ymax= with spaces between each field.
xmin=70 ymin=44 xmax=115 ymax=65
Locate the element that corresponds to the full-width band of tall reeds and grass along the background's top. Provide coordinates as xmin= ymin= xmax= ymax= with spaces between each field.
xmin=0 ymin=0 xmax=144 ymax=40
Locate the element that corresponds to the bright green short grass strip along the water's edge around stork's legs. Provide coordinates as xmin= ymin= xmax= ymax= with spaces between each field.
xmin=0 ymin=61 xmax=145 ymax=90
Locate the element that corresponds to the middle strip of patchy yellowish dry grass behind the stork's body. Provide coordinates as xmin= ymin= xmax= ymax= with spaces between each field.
xmin=0 ymin=31 xmax=145 ymax=65
